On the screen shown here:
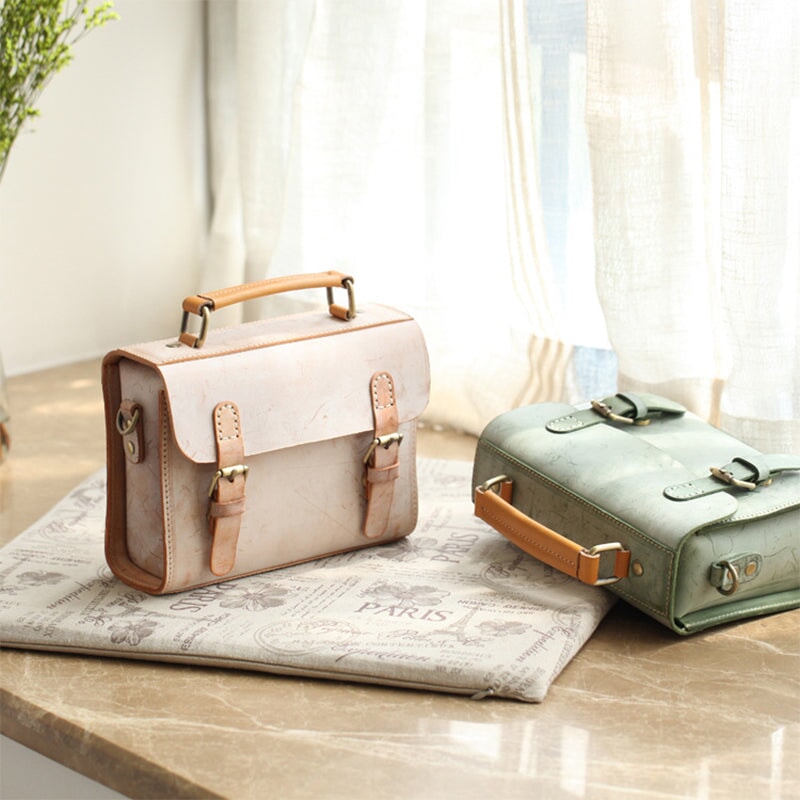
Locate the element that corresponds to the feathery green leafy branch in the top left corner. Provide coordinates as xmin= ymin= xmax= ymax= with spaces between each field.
xmin=0 ymin=0 xmax=118 ymax=178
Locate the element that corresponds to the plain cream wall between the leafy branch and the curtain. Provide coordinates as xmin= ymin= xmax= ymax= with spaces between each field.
xmin=0 ymin=0 xmax=207 ymax=376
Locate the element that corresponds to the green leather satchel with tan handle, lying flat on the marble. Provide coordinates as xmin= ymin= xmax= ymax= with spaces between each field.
xmin=473 ymin=393 xmax=800 ymax=634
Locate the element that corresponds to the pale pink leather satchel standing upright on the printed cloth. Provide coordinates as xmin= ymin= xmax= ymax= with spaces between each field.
xmin=103 ymin=272 xmax=430 ymax=594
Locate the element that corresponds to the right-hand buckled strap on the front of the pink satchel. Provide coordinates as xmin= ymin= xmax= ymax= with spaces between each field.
xmin=364 ymin=372 xmax=400 ymax=539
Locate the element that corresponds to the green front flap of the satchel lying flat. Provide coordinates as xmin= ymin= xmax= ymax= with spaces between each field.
xmin=475 ymin=403 xmax=800 ymax=548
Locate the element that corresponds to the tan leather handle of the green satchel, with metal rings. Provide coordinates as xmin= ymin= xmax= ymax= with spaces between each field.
xmin=475 ymin=475 xmax=631 ymax=586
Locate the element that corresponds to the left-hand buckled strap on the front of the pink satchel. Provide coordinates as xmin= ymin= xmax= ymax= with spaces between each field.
xmin=208 ymin=402 xmax=247 ymax=576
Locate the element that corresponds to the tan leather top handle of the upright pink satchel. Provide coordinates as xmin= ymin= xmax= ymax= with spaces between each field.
xmin=183 ymin=270 xmax=356 ymax=347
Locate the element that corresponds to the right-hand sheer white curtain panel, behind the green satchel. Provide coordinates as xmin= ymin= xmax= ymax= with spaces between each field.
xmin=587 ymin=0 xmax=800 ymax=452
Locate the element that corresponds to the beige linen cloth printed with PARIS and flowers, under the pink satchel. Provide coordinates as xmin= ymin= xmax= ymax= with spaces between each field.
xmin=0 ymin=459 xmax=614 ymax=702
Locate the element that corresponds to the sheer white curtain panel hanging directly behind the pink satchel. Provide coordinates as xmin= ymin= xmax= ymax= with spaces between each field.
xmin=203 ymin=0 xmax=599 ymax=432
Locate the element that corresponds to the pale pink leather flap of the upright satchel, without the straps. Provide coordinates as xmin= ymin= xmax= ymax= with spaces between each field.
xmin=116 ymin=305 xmax=430 ymax=463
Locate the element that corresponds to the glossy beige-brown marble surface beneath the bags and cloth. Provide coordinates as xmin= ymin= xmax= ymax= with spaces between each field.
xmin=0 ymin=361 xmax=800 ymax=800
